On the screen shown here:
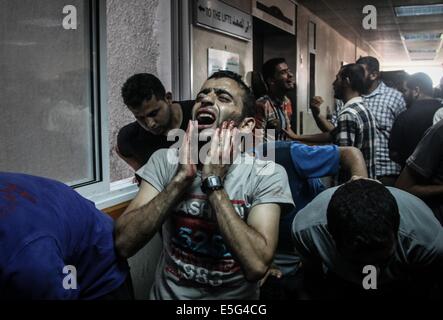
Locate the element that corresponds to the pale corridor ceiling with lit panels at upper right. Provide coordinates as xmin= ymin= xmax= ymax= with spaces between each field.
xmin=298 ymin=0 xmax=443 ymax=65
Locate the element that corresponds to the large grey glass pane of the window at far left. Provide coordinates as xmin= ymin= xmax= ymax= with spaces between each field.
xmin=0 ymin=0 xmax=95 ymax=185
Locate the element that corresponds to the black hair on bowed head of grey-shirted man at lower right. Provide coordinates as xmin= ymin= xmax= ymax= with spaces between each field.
xmin=327 ymin=179 xmax=400 ymax=253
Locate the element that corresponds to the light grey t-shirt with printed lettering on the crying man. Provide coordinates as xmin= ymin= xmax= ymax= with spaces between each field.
xmin=137 ymin=149 xmax=293 ymax=300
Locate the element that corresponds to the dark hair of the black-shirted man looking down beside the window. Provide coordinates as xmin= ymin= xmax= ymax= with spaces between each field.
xmin=122 ymin=73 xmax=166 ymax=109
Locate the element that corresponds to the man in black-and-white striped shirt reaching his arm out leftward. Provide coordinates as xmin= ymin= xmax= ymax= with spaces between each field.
xmin=287 ymin=64 xmax=377 ymax=181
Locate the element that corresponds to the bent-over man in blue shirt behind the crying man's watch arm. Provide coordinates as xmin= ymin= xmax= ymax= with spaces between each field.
xmin=261 ymin=141 xmax=367 ymax=299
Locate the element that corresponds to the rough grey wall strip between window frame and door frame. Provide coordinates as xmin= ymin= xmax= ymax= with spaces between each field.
xmin=106 ymin=0 xmax=172 ymax=181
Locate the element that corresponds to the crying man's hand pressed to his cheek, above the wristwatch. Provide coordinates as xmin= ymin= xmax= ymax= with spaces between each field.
xmin=202 ymin=121 xmax=239 ymax=180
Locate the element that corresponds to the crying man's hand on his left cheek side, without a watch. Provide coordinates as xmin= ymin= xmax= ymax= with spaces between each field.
xmin=177 ymin=121 xmax=198 ymax=181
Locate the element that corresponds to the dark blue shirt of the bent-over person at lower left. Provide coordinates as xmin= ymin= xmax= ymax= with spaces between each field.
xmin=0 ymin=173 xmax=128 ymax=299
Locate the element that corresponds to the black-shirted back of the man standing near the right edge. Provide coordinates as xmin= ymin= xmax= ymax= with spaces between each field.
xmin=389 ymin=99 xmax=442 ymax=167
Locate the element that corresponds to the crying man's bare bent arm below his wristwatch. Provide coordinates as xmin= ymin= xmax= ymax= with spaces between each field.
xmin=209 ymin=190 xmax=280 ymax=281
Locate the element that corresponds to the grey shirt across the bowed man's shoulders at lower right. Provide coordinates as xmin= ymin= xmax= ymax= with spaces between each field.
xmin=292 ymin=187 xmax=443 ymax=285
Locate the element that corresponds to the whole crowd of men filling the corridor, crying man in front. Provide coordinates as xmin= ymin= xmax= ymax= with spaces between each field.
xmin=0 ymin=57 xmax=443 ymax=300
